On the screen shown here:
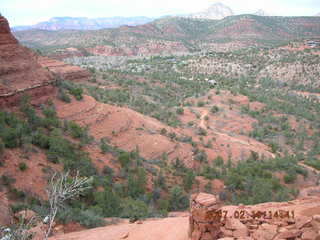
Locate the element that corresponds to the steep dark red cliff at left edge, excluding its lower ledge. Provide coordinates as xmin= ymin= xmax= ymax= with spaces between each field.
xmin=0 ymin=17 xmax=55 ymax=106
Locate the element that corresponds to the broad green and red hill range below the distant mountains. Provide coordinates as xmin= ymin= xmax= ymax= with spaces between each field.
xmin=15 ymin=15 xmax=320 ymax=56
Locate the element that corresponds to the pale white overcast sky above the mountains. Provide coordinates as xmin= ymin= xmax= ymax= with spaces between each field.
xmin=0 ymin=0 xmax=320 ymax=26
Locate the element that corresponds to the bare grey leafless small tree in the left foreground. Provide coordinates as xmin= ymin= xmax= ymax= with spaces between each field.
xmin=45 ymin=172 xmax=92 ymax=240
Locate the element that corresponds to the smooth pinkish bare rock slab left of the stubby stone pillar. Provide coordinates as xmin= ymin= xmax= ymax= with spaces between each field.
xmin=50 ymin=217 xmax=189 ymax=240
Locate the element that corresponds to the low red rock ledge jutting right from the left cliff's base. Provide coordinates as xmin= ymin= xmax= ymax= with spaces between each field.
xmin=39 ymin=57 xmax=90 ymax=81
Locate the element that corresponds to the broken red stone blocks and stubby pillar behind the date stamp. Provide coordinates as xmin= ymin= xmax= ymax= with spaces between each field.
xmin=189 ymin=193 xmax=320 ymax=240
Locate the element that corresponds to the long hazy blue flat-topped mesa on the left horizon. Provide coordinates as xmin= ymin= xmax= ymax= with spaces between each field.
xmin=13 ymin=17 xmax=154 ymax=31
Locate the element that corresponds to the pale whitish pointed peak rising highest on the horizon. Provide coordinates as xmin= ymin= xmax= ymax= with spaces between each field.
xmin=187 ymin=3 xmax=234 ymax=19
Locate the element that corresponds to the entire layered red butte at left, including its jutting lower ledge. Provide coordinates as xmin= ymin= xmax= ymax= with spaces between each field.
xmin=0 ymin=17 xmax=90 ymax=107
